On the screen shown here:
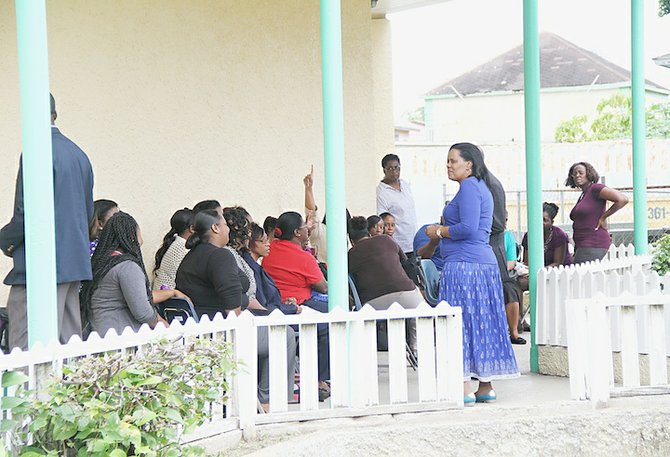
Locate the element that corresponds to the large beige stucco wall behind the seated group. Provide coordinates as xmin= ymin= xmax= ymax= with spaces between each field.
xmin=0 ymin=0 xmax=393 ymax=303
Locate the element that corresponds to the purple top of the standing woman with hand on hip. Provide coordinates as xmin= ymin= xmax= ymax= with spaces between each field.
xmin=570 ymin=183 xmax=611 ymax=249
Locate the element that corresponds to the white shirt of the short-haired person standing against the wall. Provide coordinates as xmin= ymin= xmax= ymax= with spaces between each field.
xmin=377 ymin=179 xmax=416 ymax=252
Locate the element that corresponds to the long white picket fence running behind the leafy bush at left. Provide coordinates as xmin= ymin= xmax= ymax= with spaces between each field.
xmin=0 ymin=302 xmax=463 ymax=442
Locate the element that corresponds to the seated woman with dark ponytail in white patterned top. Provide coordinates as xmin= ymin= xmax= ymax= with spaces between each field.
xmin=153 ymin=208 xmax=194 ymax=290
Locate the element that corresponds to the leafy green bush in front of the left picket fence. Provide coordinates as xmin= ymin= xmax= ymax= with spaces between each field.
xmin=0 ymin=339 xmax=236 ymax=457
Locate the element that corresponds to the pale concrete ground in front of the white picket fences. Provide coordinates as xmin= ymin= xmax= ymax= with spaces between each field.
xmin=211 ymin=333 xmax=670 ymax=457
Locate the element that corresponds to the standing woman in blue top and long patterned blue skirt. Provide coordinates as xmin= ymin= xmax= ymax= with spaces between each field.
xmin=426 ymin=143 xmax=519 ymax=405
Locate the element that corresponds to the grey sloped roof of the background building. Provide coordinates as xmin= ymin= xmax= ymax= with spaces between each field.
xmin=426 ymin=33 xmax=665 ymax=96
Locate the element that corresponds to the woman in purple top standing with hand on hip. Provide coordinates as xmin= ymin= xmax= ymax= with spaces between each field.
xmin=565 ymin=162 xmax=628 ymax=264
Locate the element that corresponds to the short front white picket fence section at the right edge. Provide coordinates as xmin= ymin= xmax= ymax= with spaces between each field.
xmin=567 ymin=292 xmax=670 ymax=407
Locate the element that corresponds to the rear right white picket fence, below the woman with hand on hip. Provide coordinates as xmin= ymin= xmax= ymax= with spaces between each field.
xmin=535 ymin=246 xmax=668 ymax=351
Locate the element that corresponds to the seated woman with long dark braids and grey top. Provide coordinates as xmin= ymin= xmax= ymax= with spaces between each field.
xmin=80 ymin=212 xmax=172 ymax=335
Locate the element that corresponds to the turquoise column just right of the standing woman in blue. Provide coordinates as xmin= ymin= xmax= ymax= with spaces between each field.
xmin=523 ymin=0 xmax=544 ymax=373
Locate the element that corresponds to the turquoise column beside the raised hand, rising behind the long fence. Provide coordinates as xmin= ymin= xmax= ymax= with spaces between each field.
xmin=321 ymin=0 xmax=349 ymax=310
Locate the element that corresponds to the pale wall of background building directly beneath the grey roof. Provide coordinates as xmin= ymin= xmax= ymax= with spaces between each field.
xmin=429 ymin=87 xmax=669 ymax=143
